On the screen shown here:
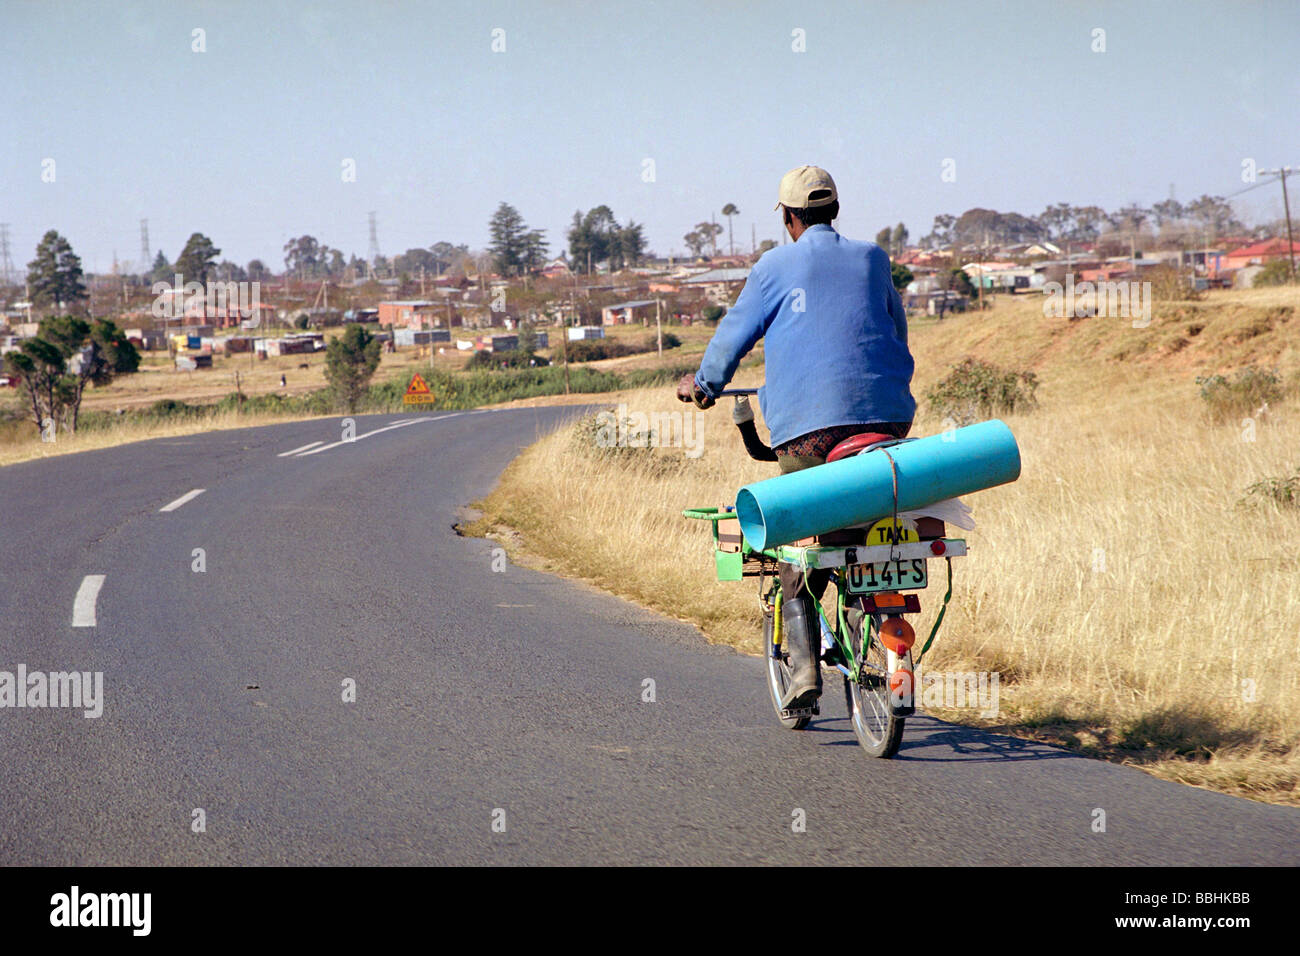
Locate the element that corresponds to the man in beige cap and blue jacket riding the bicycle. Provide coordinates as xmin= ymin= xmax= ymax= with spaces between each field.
xmin=677 ymin=166 xmax=917 ymax=709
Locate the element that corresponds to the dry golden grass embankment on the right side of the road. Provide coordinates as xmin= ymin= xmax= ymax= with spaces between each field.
xmin=471 ymin=290 xmax=1300 ymax=805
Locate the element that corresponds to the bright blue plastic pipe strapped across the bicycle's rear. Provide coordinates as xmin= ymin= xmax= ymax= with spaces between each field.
xmin=736 ymin=419 xmax=1021 ymax=550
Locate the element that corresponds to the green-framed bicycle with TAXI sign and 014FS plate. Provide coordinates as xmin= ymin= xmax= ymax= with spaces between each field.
xmin=683 ymin=389 xmax=966 ymax=758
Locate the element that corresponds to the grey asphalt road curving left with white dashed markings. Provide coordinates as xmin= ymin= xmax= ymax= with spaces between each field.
xmin=0 ymin=408 xmax=1300 ymax=865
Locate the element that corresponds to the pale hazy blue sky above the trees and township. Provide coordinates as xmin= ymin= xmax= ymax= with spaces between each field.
xmin=0 ymin=0 xmax=1300 ymax=271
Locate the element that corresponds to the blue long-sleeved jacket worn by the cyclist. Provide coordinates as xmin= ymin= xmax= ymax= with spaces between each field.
xmin=696 ymin=224 xmax=917 ymax=447
